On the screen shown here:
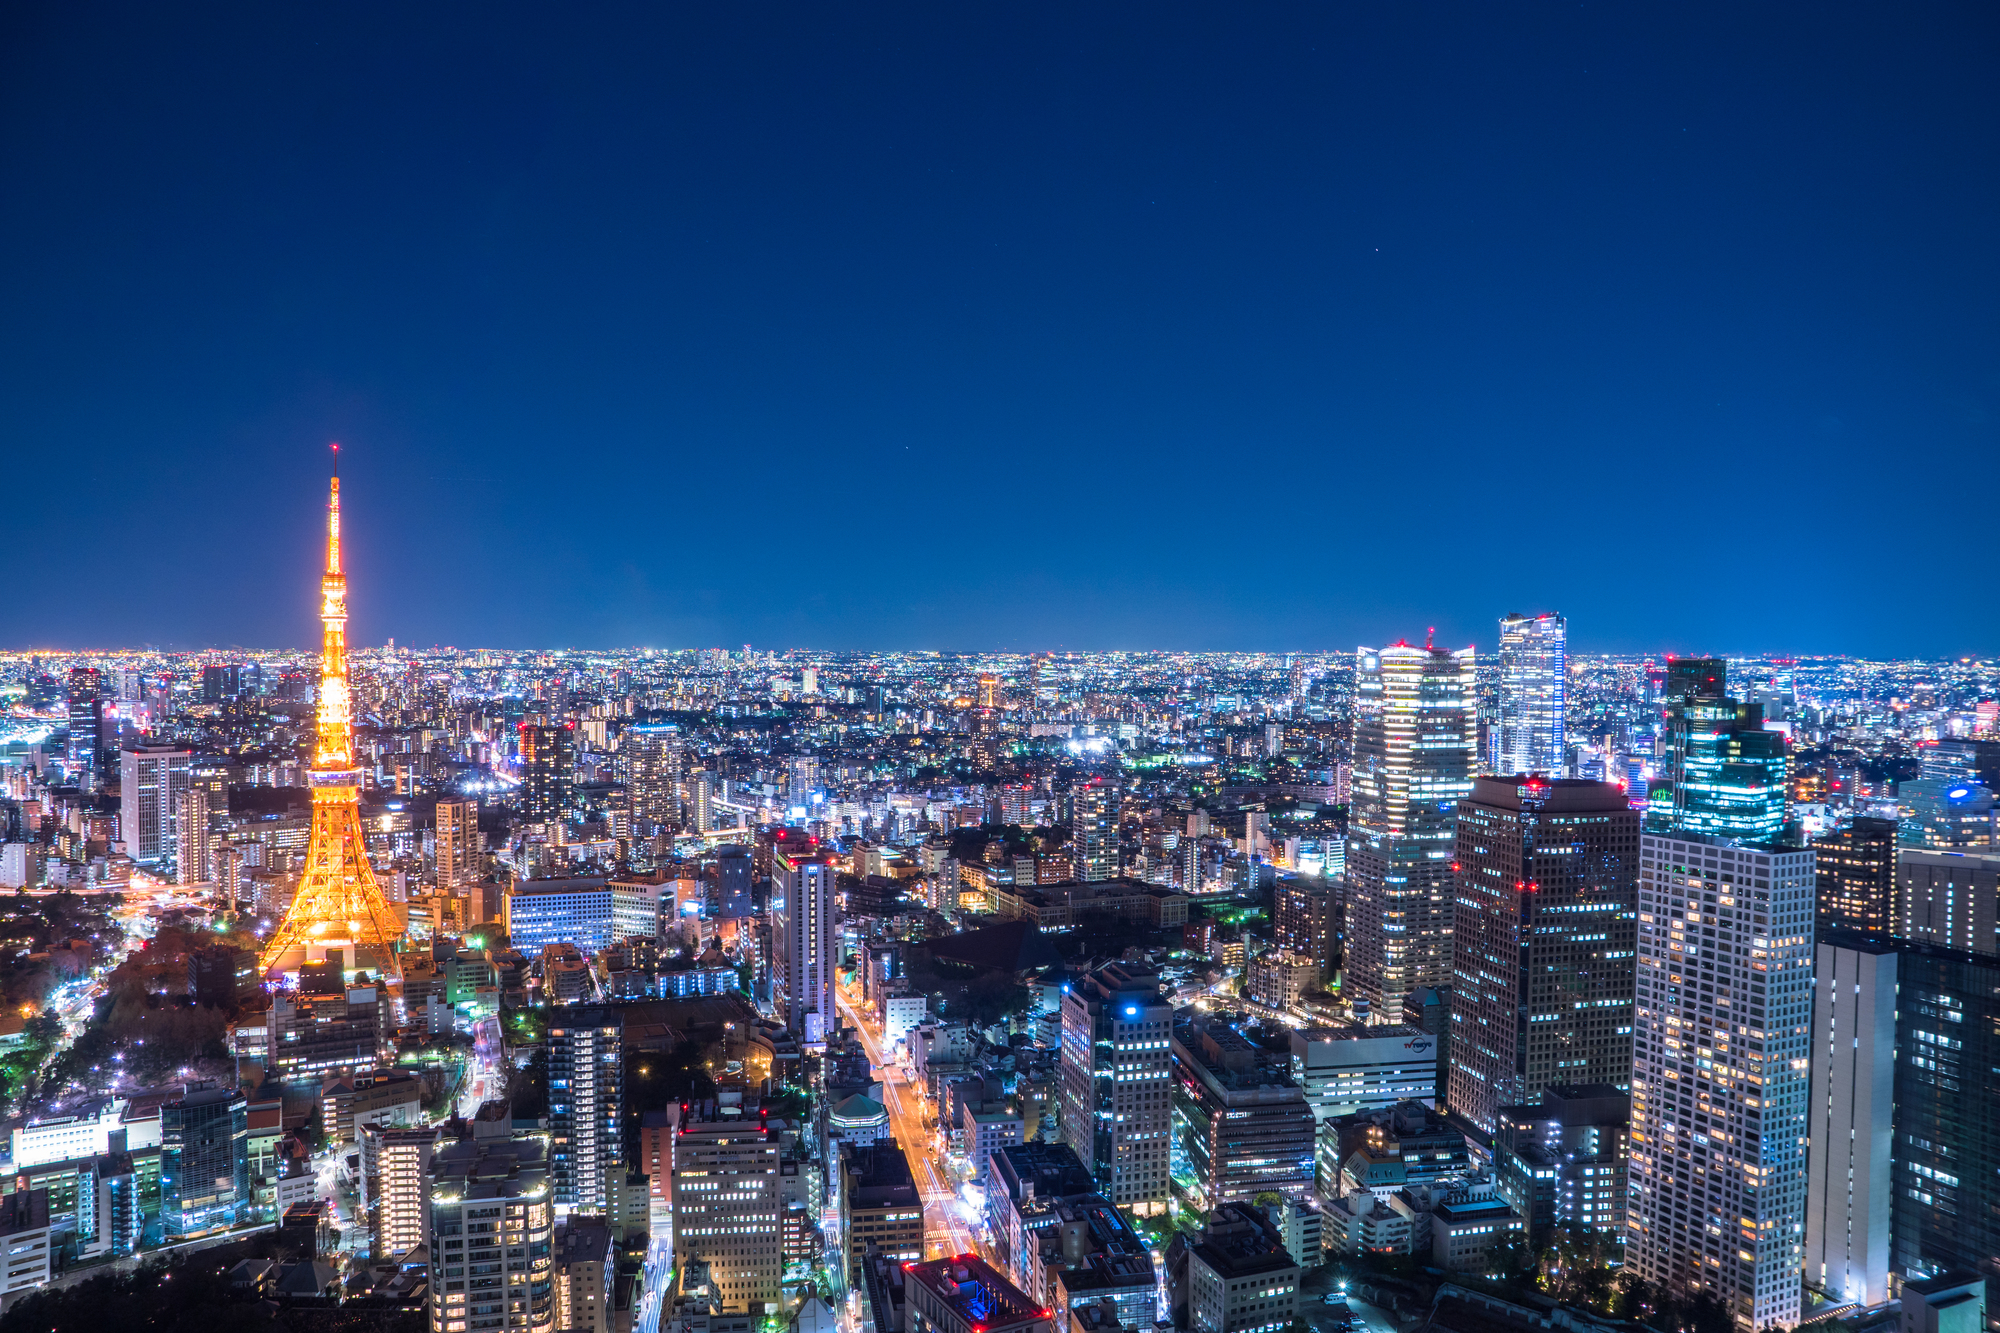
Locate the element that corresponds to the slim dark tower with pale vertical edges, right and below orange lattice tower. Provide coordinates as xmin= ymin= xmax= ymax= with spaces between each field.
xmin=548 ymin=1005 xmax=624 ymax=1213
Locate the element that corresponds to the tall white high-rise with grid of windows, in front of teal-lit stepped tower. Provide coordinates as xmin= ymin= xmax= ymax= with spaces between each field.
xmin=1626 ymin=835 xmax=1814 ymax=1333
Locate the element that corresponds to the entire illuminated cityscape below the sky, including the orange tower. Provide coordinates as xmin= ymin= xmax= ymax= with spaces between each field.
xmin=0 ymin=480 xmax=2000 ymax=1333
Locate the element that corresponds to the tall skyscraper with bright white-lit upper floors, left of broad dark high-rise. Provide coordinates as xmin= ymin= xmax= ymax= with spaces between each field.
xmin=1348 ymin=642 xmax=1478 ymax=1009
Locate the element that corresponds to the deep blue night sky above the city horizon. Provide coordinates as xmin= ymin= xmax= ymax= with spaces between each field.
xmin=0 ymin=2 xmax=2000 ymax=654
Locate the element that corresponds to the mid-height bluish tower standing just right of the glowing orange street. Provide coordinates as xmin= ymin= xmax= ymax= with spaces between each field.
xmin=1062 ymin=963 xmax=1174 ymax=1213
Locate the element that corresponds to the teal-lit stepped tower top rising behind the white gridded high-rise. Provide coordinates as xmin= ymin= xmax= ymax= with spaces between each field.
xmin=1646 ymin=656 xmax=1790 ymax=847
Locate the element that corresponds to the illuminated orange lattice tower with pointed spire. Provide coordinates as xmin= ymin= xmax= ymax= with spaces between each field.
xmin=262 ymin=444 xmax=404 ymax=973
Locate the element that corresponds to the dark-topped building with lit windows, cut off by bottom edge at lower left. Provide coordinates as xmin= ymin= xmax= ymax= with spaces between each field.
xmin=428 ymin=1133 xmax=556 ymax=1333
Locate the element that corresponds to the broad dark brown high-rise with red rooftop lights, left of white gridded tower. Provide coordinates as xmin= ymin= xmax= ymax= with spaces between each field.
xmin=1450 ymin=775 xmax=1640 ymax=1135
